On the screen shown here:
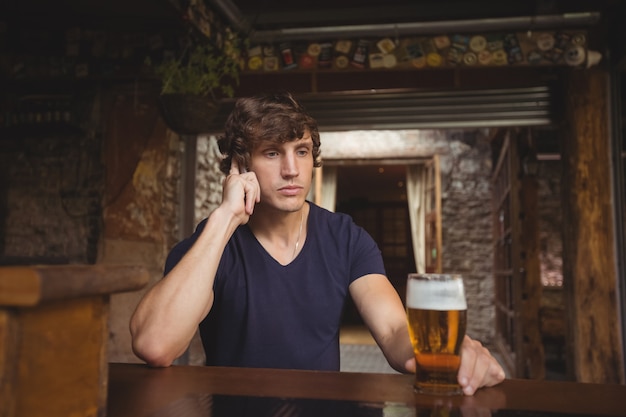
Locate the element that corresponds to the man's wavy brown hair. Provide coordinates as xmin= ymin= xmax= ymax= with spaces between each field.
xmin=217 ymin=91 xmax=322 ymax=175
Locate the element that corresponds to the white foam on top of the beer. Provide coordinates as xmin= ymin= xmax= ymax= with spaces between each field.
xmin=406 ymin=279 xmax=467 ymax=311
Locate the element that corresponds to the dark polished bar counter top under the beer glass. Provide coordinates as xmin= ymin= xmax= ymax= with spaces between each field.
xmin=107 ymin=364 xmax=626 ymax=417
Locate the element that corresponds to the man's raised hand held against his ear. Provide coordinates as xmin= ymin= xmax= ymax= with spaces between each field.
xmin=222 ymin=158 xmax=261 ymax=224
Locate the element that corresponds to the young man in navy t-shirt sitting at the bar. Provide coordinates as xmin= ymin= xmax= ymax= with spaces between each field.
xmin=130 ymin=93 xmax=504 ymax=395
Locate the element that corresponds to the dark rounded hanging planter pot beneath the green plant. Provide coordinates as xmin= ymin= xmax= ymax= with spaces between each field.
xmin=159 ymin=94 xmax=219 ymax=135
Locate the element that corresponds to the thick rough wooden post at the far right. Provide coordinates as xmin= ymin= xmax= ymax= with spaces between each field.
xmin=562 ymin=68 xmax=624 ymax=383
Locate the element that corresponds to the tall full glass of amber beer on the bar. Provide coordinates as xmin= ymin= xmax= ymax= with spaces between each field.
xmin=406 ymin=274 xmax=467 ymax=395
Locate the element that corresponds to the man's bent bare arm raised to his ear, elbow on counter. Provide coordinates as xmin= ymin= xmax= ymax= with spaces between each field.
xmin=130 ymin=161 xmax=260 ymax=366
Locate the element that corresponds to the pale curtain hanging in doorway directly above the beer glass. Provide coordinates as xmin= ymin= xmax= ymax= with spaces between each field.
xmin=406 ymin=165 xmax=426 ymax=272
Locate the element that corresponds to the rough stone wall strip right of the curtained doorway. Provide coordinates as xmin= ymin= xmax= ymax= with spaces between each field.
xmin=441 ymin=131 xmax=495 ymax=343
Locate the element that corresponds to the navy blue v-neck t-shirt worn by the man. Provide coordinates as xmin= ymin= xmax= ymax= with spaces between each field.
xmin=165 ymin=203 xmax=385 ymax=370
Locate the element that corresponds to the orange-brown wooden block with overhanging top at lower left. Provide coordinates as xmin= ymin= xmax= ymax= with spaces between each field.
xmin=0 ymin=265 xmax=148 ymax=417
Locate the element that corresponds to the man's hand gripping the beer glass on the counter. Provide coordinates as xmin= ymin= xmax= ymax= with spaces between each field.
xmin=405 ymin=335 xmax=505 ymax=395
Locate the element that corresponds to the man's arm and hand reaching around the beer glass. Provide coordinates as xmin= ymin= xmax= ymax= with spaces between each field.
xmin=350 ymin=274 xmax=504 ymax=395
